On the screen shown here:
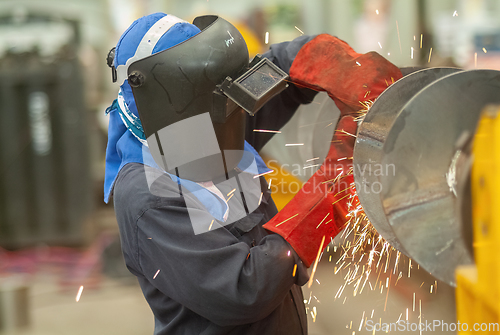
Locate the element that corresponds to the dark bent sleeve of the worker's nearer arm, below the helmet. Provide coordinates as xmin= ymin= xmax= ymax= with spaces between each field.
xmin=136 ymin=193 xmax=308 ymax=326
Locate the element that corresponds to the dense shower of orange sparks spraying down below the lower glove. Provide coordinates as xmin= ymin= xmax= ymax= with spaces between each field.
xmin=308 ymin=100 xmax=430 ymax=329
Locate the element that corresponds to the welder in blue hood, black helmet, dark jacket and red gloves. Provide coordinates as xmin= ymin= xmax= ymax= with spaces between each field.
xmin=104 ymin=13 xmax=401 ymax=335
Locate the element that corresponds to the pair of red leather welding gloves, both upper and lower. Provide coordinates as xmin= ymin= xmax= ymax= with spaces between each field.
xmin=264 ymin=34 xmax=402 ymax=266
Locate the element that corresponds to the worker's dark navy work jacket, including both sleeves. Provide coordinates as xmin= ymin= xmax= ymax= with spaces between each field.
xmin=113 ymin=36 xmax=314 ymax=335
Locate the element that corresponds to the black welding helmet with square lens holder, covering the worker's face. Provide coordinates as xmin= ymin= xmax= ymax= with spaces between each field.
xmin=109 ymin=15 xmax=287 ymax=182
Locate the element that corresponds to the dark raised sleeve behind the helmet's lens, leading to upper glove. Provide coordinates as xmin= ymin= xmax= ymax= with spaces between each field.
xmin=245 ymin=35 xmax=317 ymax=151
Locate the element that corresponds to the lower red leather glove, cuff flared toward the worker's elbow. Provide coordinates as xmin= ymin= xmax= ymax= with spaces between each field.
xmin=264 ymin=116 xmax=357 ymax=267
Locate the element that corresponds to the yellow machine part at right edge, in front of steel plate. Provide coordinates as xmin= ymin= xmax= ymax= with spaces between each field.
xmin=456 ymin=106 xmax=500 ymax=335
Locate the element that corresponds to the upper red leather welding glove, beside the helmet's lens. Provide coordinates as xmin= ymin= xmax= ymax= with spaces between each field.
xmin=290 ymin=34 xmax=402 ymax=115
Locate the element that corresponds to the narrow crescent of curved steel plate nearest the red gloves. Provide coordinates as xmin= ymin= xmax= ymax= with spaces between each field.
xmin=354 ymin=68 xmax=461 ymax=255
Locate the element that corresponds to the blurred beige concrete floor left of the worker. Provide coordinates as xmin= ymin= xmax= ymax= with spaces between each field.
xmin=7 ymin=278 xmax=153 ymax=335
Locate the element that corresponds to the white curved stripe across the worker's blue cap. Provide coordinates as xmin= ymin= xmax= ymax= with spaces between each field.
xmin=116 ymin=14 xmax=186 ymax=85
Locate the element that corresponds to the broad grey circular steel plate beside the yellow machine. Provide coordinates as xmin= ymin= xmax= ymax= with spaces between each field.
xmin=379 ymin=70 xmax=500 ymax=284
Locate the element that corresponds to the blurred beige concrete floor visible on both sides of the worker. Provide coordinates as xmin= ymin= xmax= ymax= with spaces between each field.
xmin=0 ymin=262 xmax=454 ymax=335
